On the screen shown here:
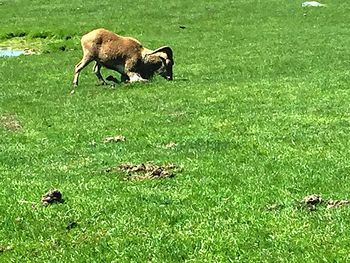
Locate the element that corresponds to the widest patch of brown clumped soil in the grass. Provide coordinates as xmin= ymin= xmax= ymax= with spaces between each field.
xmin=118 ymin=163 xmax=176 ymax=180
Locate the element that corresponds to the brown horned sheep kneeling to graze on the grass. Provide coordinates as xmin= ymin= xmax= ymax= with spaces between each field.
xmin=73 ymin=28 xmax=174 ymax=86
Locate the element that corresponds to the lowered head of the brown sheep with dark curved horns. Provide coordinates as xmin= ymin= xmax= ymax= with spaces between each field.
xmin=147 ymin=46 xmax=174 ymax=80
